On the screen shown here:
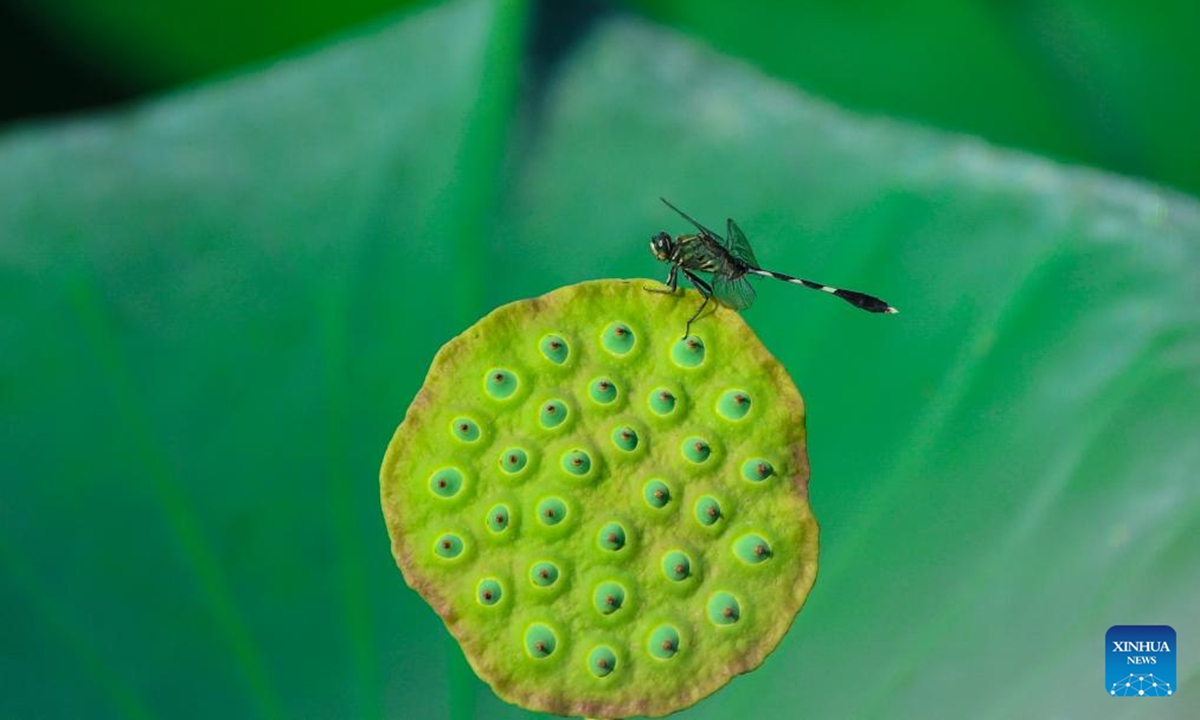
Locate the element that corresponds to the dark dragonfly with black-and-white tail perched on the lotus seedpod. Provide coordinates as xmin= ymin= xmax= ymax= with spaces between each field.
xmin=646 ymin=198 xmax=900 ymax=337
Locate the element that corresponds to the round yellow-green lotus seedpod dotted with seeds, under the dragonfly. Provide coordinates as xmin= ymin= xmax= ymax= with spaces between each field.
xmin=380 ymin=281 xmax=817 ymax=719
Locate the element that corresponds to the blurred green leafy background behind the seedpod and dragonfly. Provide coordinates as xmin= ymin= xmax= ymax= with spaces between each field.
xmin=0 ymin=0 xmax=1200 ymax=720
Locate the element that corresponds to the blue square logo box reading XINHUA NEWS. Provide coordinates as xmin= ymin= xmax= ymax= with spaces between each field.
xmin=1104 ymin=625 xmax=1177 ymax=697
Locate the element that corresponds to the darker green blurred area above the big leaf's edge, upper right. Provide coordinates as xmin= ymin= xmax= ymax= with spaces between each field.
xmin=628 ymin=0 xmax=1200 ymax=193
